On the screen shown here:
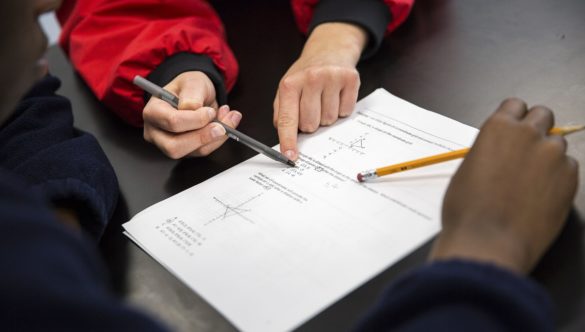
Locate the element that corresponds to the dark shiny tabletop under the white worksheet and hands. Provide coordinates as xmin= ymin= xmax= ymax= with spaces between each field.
xmin=49 ymin=0 xmax=585 ymax=331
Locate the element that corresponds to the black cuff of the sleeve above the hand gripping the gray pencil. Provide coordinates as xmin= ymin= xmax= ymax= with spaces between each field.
xmin=144 ymin=52 xmax=227 ymax=105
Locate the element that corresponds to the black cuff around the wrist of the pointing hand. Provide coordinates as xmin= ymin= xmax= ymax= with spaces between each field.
xmin=309 ymin=0 xmax=392 ymax=59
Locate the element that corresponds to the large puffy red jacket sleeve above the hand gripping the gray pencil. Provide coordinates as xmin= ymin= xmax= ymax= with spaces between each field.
xmin=58 ymin=0 xmax=238 ymax=126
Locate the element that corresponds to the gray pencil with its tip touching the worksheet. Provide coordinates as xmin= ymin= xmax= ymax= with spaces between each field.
xmin=134 ymin=75 xmax=295 ymax=167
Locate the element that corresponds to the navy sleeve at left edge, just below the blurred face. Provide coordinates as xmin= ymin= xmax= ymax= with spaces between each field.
xmin=0 ymin=76 xmax=118 ymax=239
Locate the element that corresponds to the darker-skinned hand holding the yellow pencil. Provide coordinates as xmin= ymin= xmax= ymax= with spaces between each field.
xmin=431 ymin=99 xmax=578 ymax=273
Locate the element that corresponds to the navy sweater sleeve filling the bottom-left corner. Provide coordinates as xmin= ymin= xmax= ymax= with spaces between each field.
xmin=0 ymin=169 xmax=169 ymax=331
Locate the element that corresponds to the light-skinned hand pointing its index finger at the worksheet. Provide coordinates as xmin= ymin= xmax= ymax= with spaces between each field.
xmin=273 ymin=23 xmax=367 ymax=160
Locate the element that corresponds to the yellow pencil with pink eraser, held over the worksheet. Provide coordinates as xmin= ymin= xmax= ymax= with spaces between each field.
xmin=357 ymin=125 xmax=585 ymax=182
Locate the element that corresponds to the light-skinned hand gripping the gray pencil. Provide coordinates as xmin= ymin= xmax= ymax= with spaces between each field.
xmin=142 ymin=71 xmax=242 ymax=159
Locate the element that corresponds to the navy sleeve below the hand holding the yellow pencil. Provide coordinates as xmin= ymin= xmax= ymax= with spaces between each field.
xmin=356 ymin=261 xmax=554 ymax=332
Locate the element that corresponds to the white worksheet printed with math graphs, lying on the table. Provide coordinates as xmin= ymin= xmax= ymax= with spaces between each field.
xmin=124 ymin=89 xmax=477 ymax=331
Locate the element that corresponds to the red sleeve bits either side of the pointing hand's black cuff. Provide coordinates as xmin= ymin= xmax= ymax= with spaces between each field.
xmin=292 ymin=0 xmax=414 ymax=33
